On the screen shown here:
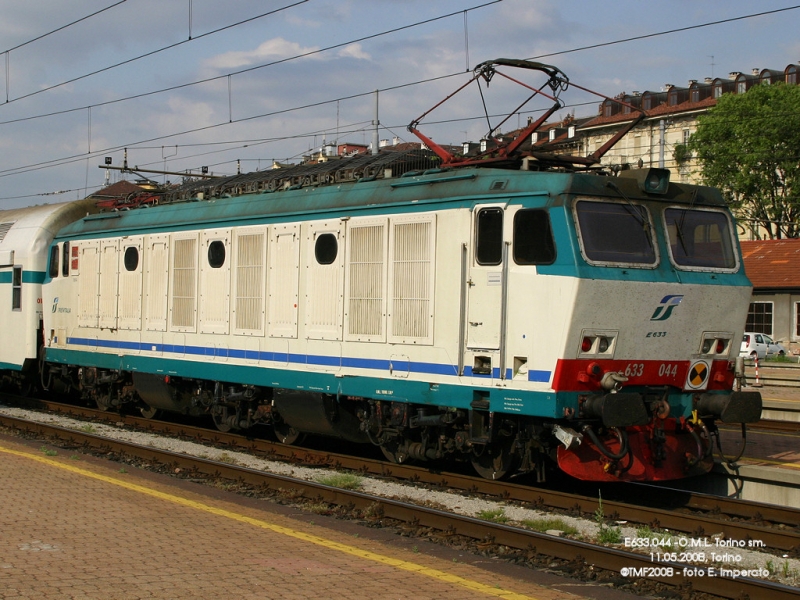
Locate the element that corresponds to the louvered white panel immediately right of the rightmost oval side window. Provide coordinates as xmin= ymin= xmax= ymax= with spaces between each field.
xmin=346 ymin=219 xmax=386 ymax=341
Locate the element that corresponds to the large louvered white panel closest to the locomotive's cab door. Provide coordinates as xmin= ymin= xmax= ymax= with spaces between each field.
xmin=390 ymin=216 xmax=434 ymax=343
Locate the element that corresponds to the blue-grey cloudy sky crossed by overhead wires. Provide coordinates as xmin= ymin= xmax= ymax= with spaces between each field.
xmin=0 ymin=0 xmax=800 ymax=210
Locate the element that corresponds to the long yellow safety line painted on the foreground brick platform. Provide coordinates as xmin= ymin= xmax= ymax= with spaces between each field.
xmin=0 ymin=446 xmax=535 ymax=600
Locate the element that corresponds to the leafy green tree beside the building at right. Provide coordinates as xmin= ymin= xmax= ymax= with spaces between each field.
xmin=689 ymin=83 xmax=800 ymax=239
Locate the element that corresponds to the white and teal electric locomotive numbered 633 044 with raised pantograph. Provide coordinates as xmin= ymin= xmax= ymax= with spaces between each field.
xmin=43 ymin=59 xmax=761 ymax=481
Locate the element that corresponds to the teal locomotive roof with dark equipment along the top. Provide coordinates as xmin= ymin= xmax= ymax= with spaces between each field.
xmin=59 ymin=150 xmax=724 ymax=238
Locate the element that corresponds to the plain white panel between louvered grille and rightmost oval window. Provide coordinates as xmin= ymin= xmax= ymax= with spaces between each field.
xmin=268 ymin=225 xmax=300 ymax=338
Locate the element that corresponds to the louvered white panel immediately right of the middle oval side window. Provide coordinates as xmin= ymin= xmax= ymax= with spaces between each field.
xmin=233 ymin=231 xmax=266 ymax=335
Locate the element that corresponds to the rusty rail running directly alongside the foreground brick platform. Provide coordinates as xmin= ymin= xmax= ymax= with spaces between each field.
xmin=0 ymin=416 xmax=800 ymax=600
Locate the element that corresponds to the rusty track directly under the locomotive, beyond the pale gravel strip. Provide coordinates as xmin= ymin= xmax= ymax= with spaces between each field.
xmin=0 ymin=401 xmax=800 ymax=555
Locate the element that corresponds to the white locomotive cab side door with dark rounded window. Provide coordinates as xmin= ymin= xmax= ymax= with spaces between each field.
xmin=465 ymin=205 xmax=505 ymax=350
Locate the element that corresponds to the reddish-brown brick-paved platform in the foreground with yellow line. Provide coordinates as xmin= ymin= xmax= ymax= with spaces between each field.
xmin=0 ymin=435 xmax=633 ymax=600
